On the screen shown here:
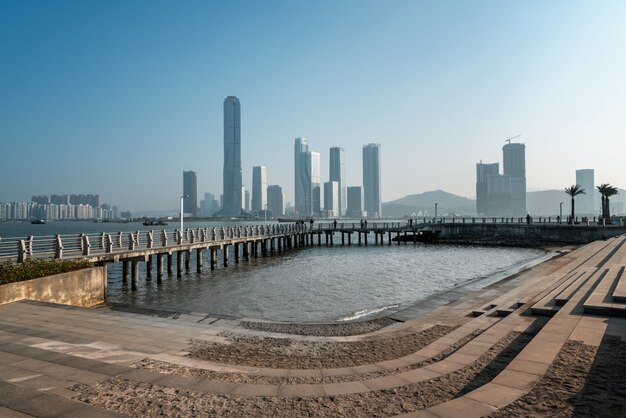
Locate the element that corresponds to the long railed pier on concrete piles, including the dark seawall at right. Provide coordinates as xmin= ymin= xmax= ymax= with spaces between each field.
xmin=0 ymin=218 xmax=626 ymax=290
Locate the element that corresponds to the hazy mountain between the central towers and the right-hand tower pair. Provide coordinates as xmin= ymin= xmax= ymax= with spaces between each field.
xmin=382 ymin=190 xmax=476 ymax=217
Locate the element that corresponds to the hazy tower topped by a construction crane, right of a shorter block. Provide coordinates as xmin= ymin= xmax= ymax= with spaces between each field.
xmin=502 ymin=143 xmax=527 ymax=216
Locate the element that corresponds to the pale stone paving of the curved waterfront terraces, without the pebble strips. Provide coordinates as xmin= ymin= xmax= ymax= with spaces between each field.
xmin=0 ymin=237 xmax=626 ymax=417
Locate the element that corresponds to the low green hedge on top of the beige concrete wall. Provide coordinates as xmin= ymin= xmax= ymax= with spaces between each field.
xmin=0 ymin=260 xmax=92 ymax=285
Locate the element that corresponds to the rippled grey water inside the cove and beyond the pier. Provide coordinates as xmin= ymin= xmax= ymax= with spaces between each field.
xmin=0 ymin=222 xmax=545 ymax=322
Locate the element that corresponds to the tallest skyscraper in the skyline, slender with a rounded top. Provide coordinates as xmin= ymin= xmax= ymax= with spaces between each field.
xmin=222 ymin=96 xmax=243 ymax=216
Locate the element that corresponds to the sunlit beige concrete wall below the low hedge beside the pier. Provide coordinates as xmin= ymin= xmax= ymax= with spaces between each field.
xmin=0 ymin=267 xmax=107 ymax=306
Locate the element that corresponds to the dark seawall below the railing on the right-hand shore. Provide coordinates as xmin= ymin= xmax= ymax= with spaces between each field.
xmin=437 ymin=223 xmax=626 ymax=246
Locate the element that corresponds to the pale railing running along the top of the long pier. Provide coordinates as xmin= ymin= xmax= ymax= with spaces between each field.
xmin=0 ymin=217 xmax=616 ymax=263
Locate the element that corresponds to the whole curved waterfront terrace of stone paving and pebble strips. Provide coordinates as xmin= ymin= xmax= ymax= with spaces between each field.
xmin=0 ymin=236 xmax=626 ymax=417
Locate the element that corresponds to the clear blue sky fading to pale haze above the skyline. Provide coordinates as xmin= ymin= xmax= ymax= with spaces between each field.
xmin=0 ymin=0 xmax=626 ymax=211
